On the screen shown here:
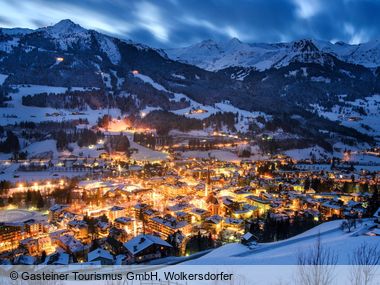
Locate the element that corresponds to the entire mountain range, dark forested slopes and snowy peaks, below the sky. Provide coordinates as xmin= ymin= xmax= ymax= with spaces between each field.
xmin=0 ymin=20 xmax=380 ymax=149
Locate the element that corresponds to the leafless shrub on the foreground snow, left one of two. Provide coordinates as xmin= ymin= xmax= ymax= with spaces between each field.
xmin=296 ymin=234 xmax=338 ymax=285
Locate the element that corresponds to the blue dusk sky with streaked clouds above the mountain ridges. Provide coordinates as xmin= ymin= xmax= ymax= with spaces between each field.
xmin=0 ymin=0 xmax=380 ymax=47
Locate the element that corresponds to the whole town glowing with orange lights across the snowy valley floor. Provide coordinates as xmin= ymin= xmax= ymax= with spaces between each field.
xmin=0 ymin=116 xmax=379 ymax=264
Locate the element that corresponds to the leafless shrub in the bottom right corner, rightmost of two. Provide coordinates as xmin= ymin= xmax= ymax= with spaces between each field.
xmin=349 ymin=242 xmax=380 ymax=285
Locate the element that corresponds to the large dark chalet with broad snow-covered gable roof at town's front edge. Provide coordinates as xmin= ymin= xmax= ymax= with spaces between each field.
xmin=124 ymin=235 xmax=172 ymax=263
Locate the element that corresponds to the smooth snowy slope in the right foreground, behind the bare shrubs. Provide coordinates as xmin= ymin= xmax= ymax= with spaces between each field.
xmin=186 ymin=220 xmax=380 ymax=265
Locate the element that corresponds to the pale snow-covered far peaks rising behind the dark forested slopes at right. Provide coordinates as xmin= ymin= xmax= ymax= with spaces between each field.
xmin=165 ymin=38 xmax=380 ymax=71
